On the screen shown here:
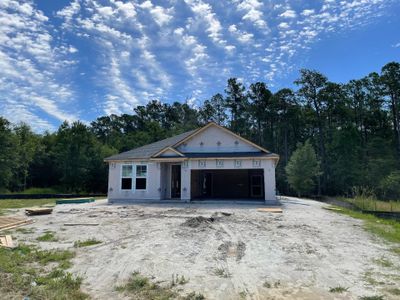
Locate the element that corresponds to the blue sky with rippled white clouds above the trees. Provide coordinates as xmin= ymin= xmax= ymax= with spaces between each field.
xmin=0 ymin=0 xmax=400 ymax=132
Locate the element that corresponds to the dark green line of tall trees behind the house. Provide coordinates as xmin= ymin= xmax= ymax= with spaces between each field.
xmin=0 ymin=62 xmax=400 ymax=198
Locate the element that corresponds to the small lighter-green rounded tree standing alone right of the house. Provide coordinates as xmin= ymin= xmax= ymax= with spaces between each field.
xmin=285 ymin=141 xmax=320 ymax=197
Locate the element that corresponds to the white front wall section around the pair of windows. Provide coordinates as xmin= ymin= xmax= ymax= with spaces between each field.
xmin=108 ymin=161 xmax=162 ymax=202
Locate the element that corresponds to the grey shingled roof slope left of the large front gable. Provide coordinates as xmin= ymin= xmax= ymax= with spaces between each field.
xmin=105 ymin=129 xmax=198 ymax=161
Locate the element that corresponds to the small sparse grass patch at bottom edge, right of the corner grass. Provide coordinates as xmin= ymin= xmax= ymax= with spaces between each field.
xmin=116 ymin=272 xmax=178 ymax=299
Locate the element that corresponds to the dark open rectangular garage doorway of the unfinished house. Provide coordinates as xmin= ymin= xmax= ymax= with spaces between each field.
xmin=191 ymin=169 xmax=264 ymax=200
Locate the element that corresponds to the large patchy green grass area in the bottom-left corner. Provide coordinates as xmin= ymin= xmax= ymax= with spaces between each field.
xmin=0 ymin=245 xmax=88 ymax=300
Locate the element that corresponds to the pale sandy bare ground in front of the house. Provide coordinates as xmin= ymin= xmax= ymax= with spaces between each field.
xmin=7 ymin=198 xmax=400 ymax=299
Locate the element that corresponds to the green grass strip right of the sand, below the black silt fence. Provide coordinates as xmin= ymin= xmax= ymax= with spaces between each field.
xmin=336 ymin=208 xmax=400 ymax=245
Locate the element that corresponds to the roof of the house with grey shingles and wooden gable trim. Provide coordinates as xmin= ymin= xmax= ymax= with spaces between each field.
xmin=104 ymin=122 xmax=279 ymax=161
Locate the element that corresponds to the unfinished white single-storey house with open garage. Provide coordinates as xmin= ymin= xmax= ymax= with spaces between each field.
xmin=105 ymin=122 xmax=279 ymax=203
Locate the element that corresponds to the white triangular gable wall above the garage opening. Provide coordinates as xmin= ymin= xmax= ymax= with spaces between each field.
xmin=177 ymin=126 xmax=260 ymax=153
